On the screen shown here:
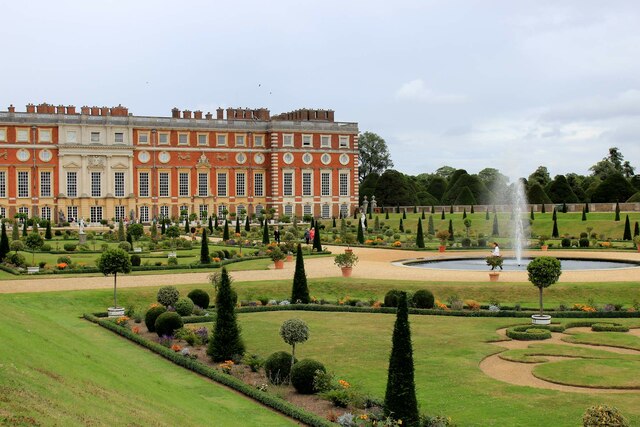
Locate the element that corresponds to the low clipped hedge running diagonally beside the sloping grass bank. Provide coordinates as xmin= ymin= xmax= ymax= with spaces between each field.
xmin=83 ymin=313 xmax=334 ymax=427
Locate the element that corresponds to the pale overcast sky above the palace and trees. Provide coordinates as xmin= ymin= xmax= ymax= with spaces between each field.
xmin=0 ymin=0 xmax=640 ymax=181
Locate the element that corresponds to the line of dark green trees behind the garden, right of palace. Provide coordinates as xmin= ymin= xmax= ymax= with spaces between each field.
xmin=359 ymin=132 xmax=640 ymax=206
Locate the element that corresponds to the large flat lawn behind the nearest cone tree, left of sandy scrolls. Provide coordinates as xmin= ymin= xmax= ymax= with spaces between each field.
xmin=239 ymin=312 xmax=640 ymax=426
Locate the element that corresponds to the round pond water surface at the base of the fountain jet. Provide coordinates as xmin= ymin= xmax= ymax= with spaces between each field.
xmin=403 ymin=258 xmax=640 ymax=271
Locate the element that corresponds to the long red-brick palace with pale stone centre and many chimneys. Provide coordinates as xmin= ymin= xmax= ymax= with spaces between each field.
xmin=0 ymin=104 xmax=358 ymax=223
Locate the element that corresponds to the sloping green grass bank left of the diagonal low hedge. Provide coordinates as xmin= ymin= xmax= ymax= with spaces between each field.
xmin=0 ymin=291 xmax=295 ymax=426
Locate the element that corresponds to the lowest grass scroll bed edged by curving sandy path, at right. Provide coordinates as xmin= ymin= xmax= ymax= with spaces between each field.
xmin=533 ymin=359 xmax=640 ymax=392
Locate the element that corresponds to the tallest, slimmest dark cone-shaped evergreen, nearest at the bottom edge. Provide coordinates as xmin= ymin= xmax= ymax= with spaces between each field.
xmin=384 ymin=292 xmax=420 ymax=426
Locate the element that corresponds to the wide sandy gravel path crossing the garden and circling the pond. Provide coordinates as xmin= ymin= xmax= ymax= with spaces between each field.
xmin=0 ymin=246 xmax=640 ymax=293
